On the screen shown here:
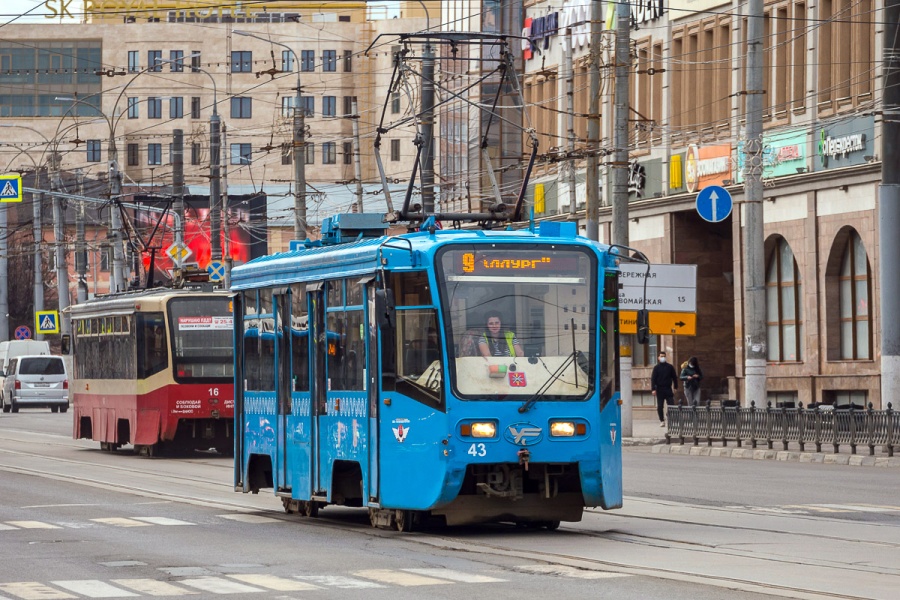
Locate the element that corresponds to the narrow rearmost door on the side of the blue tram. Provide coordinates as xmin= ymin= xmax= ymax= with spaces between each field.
xmin=273 ymin=292 xmax=292 ymax=491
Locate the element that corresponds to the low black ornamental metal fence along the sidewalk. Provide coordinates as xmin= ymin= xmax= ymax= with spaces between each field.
xmin=666 ymin=401 xmax=900 ymax=456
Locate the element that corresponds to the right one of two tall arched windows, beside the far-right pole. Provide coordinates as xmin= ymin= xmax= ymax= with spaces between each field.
xmin=840 ymin=231 xmax=872 ymax=360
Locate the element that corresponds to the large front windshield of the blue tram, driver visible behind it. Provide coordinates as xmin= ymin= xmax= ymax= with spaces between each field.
xmin=437 ymin=244 xmax=598 ymax=400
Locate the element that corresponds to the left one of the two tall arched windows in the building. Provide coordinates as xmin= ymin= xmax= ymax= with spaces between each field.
xmin=766 ymin=238 xmax=803 ymax=362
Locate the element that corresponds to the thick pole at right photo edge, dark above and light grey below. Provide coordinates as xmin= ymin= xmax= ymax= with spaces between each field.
xmin=878 ymin=0 xmax=900 ymax=408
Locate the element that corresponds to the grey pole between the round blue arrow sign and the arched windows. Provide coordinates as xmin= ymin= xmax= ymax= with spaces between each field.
xmin=744 ymin=0 xmax=767 ymax=406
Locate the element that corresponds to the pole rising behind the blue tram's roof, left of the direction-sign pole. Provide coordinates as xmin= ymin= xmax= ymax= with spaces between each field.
xmin=585 ymin=0 xmax=600 ymax=239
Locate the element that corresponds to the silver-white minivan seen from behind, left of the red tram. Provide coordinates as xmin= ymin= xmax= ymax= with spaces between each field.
xmin=0 ymin=355 xmax=69 ymax=413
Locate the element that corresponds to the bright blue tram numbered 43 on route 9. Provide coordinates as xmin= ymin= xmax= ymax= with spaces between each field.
xmin=232 ymin=218 xmax=622 ymax=531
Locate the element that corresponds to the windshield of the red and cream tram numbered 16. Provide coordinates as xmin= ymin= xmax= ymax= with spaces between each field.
xmin=169 ymin=296 xmax=234 ymax=383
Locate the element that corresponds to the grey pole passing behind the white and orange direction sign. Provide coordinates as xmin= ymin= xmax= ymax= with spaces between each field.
xmin=608 ymin=0 xmax=634 ymax=437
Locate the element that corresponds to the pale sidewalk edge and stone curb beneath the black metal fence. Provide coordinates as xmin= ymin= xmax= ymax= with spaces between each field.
xmin=622 ymin=419 xmax=900 ymax=467
